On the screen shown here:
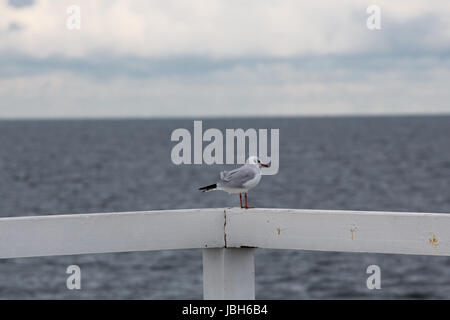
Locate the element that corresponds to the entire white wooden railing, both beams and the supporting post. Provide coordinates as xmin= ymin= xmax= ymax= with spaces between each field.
xmin=0 ymin=208 xmax=450 ymax=299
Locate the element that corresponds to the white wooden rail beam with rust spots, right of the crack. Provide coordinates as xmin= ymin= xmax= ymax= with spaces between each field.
xmin=225 ymin=209 xmax=450 ymax=256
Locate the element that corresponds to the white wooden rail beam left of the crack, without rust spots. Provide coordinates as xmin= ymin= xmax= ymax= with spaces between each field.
xmin=0 ymin=209 xmax=225 ymax=258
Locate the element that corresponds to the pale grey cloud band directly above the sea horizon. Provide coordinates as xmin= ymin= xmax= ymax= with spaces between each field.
xmin=0 ymin=58 xmax=450 ymax=118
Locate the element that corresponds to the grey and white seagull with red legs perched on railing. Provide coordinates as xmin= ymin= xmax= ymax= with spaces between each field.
xmin=198 ymin=156 xmax=268 ymax=209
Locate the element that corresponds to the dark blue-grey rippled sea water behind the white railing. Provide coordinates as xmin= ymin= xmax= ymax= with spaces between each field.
xmin=0 ymin=116 xmax=450 ymax=299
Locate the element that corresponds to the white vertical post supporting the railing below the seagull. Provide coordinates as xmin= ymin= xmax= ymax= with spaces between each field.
xmin=203 ymin=248 xmax=255 ymax=300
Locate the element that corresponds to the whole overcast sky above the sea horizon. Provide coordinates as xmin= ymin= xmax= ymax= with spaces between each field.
xmin=0 ymin=0 xmax=450 ymax=118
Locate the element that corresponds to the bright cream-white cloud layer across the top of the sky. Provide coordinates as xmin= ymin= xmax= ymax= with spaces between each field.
xmin=0 ymin=0 xmax=450 ymax=59
